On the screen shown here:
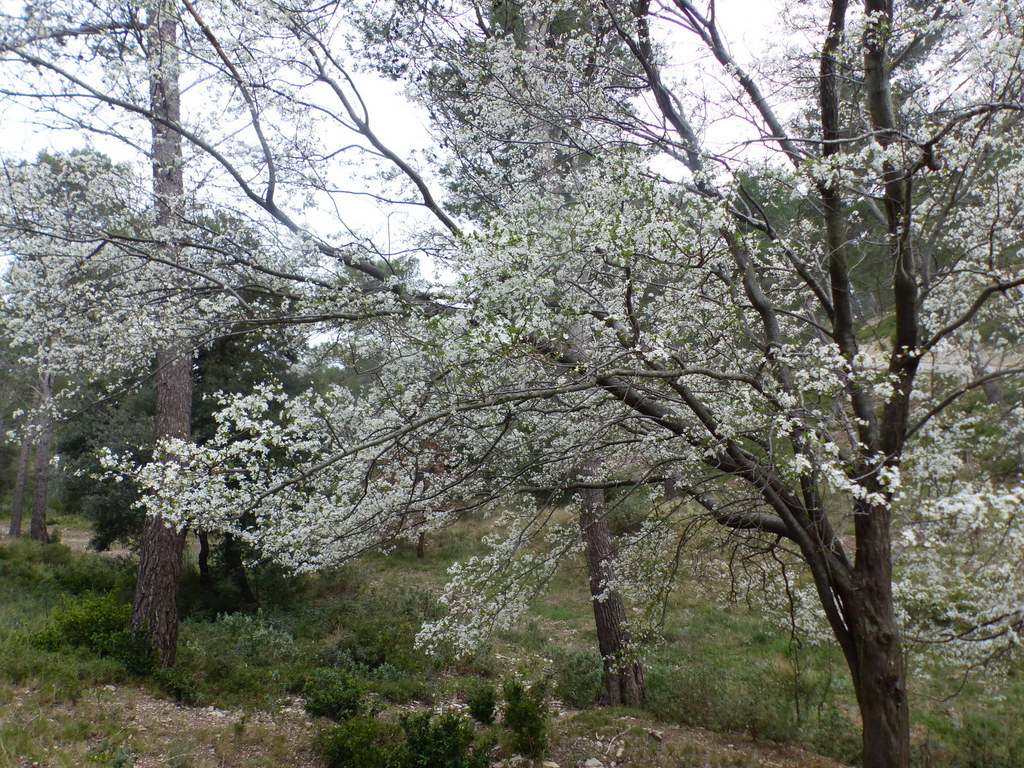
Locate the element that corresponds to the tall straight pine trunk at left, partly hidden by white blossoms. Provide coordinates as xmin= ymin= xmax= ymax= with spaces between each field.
xmin=131 ymin=3 xmax=193 ymax=667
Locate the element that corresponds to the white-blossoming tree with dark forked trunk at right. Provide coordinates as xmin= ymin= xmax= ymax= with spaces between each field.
xmin=6 ymin=0 xmax=1024 ymax=768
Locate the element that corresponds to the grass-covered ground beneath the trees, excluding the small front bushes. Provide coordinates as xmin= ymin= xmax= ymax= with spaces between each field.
xmin=0 ymin=517 xmax=1024 ymax=768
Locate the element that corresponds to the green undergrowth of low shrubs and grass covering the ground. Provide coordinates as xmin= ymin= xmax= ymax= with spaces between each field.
xmin=0 ymin=531 xmax=1024 ymax=768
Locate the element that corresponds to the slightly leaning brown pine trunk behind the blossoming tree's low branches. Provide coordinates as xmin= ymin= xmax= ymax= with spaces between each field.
xmin=580 ymin=463 xmax=644 ymax=707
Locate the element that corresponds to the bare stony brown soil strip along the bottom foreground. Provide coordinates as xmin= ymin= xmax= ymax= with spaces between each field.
xmin=0 ymin=685 xmax=840 ymax=768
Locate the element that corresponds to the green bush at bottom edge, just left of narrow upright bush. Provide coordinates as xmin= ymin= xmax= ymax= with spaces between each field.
xmin=400 ymin=710 xmax=490 ymax=768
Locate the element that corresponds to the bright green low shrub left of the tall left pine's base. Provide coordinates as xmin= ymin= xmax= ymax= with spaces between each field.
xmin=32 ymin=595 xmax=156 ymax=675
